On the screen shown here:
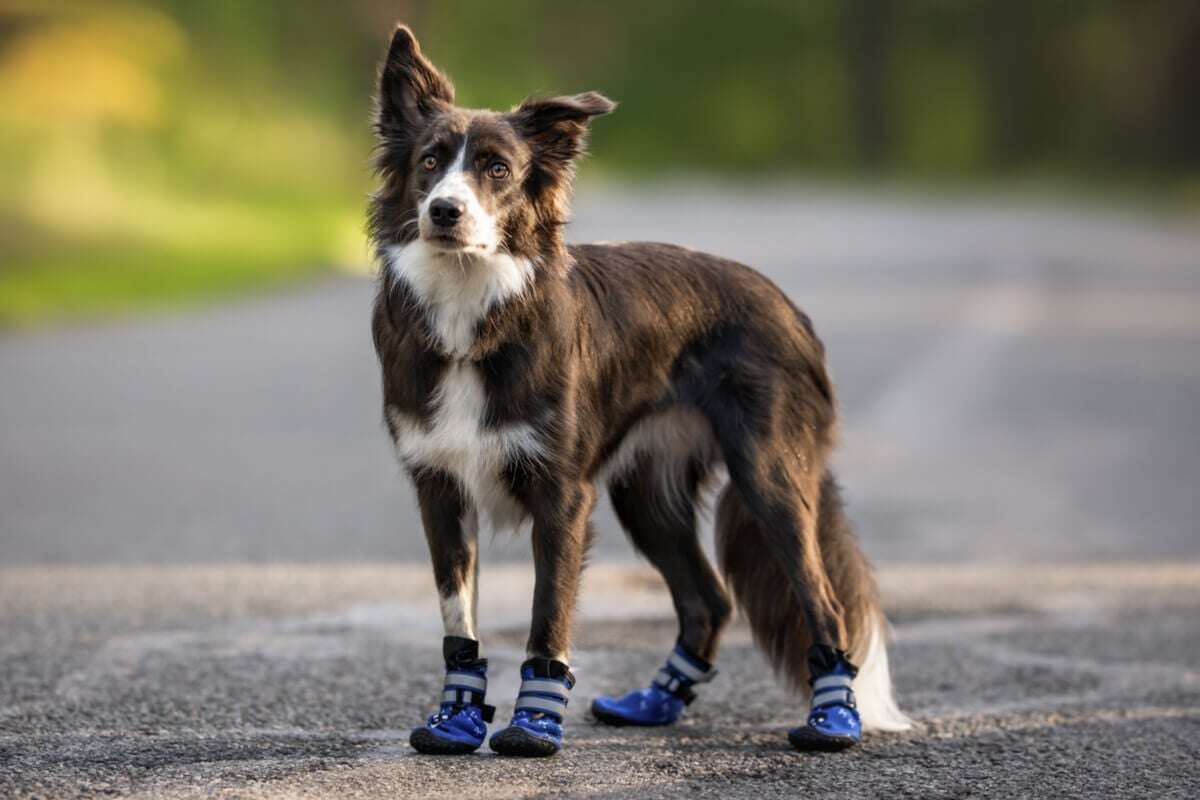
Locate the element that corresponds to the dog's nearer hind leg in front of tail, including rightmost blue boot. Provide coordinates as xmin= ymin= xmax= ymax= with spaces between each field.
xmin=714 ymin=373 xmax=883 ymax=750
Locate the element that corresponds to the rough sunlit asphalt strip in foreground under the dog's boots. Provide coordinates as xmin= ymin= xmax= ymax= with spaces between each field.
xmin=0 ymin=565 xmax=1200 ymax=800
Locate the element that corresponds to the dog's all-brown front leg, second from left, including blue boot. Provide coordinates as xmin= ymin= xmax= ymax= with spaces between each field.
xmin=491 ymin=483 xmax=595 ymax=756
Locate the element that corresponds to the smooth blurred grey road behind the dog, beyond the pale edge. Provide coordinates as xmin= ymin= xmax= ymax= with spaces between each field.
xmin=0 ymin=186 xmax=1200 ymax=563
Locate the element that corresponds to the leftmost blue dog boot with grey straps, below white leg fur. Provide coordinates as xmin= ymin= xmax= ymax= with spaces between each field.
xmin=408 ymin=636 xmax=496 ymax=756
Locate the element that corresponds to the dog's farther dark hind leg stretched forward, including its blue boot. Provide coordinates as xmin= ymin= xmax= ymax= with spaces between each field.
xmin=592 ymin=455 xmax=732 ymax=726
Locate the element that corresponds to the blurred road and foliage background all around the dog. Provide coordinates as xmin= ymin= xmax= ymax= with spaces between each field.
xmin=0 ymin=7 xmax=1200 ymax=798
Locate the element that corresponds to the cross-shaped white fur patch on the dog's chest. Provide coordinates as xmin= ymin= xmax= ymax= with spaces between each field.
xmin=388 ymin=361 xmax=545 ymax=529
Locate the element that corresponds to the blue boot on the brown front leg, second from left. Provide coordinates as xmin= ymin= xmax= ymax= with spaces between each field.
xmin=488 ymin=658 xmax=575 ymax=758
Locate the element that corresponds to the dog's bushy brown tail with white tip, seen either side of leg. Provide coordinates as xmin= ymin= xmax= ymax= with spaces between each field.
xmin=716 ymin=471 xmax=912 ymax=730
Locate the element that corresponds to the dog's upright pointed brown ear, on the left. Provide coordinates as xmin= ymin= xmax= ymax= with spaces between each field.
xmin=378 ymin=25 xmax=454 ymax=133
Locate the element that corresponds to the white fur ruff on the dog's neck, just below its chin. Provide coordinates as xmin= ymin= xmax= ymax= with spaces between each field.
xmin=385 ymin=240 xmax=536 ymax=359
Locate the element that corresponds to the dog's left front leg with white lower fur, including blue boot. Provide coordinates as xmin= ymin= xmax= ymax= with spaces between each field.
xmin=409 ymin=471 xmax=493 ymax=756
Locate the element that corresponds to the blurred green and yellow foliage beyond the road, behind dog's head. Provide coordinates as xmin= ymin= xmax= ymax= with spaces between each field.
xmin=0 ymin=0 xmax=1200 ymax=324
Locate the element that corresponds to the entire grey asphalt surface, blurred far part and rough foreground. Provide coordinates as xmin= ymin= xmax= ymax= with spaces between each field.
xmin=0 ymin=185 xmax=1200 ymax=798
